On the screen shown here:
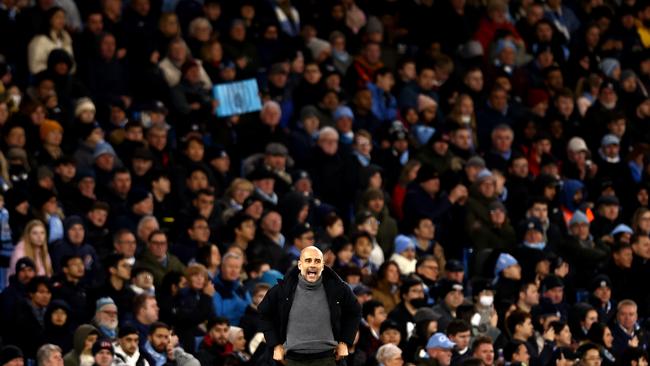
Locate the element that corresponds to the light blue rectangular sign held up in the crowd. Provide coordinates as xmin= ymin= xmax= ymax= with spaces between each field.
xmin=212 ymin=79 xmax=262 ymax=117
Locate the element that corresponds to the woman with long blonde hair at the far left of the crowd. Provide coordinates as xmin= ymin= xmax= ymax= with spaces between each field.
xmin=9 ymin=220 xmax=52 ymax=277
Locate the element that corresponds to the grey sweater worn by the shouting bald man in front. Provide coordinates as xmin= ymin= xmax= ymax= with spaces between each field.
xmin=284 ymin=275 xmax=337 ymax=354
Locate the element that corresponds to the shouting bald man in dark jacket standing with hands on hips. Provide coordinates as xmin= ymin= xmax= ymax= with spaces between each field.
xmin=259 ymin=246 xmax=361 ymax=366
